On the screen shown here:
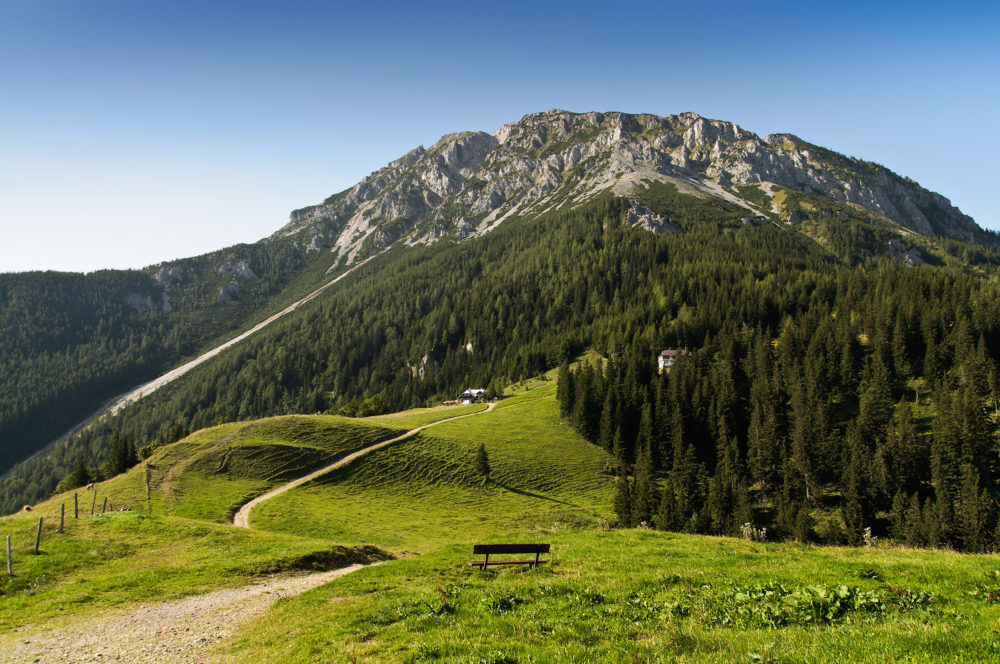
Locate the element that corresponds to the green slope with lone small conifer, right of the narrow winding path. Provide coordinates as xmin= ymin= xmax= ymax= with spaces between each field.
xmin=250 ymin=382 xmax=612 ymax=551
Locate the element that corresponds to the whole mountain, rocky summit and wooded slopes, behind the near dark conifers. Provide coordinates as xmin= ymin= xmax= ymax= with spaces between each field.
xmin=0 ymin=111 xmax=1000 ymax=510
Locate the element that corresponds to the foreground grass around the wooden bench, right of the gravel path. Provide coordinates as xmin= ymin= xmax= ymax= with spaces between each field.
xmin=219 ymin=530 xmax=1000 ymax=664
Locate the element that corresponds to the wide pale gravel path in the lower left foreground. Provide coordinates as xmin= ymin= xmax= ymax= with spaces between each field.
xmin=0 ymin=565 xmax=364 ymax=664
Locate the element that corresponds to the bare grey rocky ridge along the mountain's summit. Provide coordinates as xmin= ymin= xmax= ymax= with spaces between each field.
xmin=276 ymin=109 xmax=982 ymax=262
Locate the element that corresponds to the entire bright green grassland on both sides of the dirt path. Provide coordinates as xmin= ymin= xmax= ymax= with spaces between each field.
xmin=0 ymin=380 xmax=1000 ymax=663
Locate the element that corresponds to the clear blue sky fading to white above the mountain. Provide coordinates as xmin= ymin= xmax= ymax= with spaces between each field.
xmin=0 ymin=0 xmax=1000 ymax=272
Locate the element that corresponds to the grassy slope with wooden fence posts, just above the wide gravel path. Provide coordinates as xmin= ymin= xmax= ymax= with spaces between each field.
xmin=0 ymin=512 xmax=380 ymax=632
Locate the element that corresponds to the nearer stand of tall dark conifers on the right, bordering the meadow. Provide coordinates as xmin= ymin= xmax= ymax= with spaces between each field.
xmin=559 ymin=268 xmax=1000 ymax=551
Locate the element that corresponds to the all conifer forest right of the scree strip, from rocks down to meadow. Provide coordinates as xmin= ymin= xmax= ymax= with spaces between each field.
xmin=0 ymin=188 xmax=1000 ymax=551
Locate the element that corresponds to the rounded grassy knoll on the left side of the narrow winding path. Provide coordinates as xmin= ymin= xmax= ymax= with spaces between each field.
xmin=33 ymin=415 xmax=405 ymax=523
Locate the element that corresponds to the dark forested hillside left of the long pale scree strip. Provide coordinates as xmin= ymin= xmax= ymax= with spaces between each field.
xmin=0 ymin=240 xmax=344 ymax=475
